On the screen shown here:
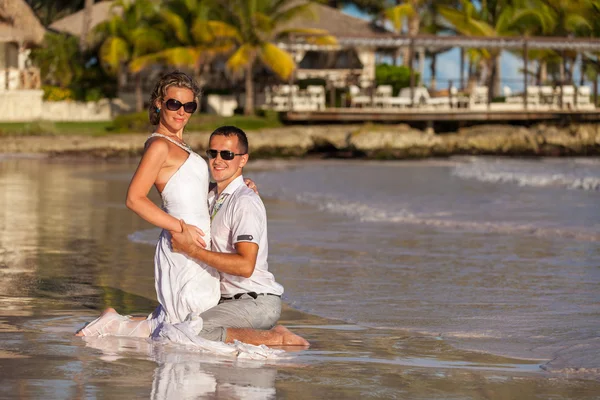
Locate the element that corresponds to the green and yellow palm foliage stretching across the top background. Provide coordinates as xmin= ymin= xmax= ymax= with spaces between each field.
xmin=27 ymin=0 xmax=600 ymax=114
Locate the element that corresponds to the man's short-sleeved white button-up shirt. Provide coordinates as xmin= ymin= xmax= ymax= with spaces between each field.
xmin=208 ymin=176 xmax=283 ymax=297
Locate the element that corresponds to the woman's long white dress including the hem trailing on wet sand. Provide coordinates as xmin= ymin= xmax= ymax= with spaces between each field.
xmin=82 ymin=133 xmax=283 ymax=360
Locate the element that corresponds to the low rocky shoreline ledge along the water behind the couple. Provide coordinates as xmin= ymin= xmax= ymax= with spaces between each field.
xmin=0 ymin=124 xmax=600 ymax=160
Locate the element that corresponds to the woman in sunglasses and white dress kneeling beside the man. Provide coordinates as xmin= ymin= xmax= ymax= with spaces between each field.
xmin=77 ymin=71 xmax=220 ymax=337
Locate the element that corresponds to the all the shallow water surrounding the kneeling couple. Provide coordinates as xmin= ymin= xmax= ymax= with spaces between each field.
xmin=0 ymin=158 xmax=600 ymax=399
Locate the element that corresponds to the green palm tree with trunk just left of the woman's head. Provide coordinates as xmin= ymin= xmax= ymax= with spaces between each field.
xmin=96 ymin=0 xmax=165 ymax=111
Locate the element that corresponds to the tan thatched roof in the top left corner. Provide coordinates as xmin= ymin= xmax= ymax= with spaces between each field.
xmin=0 ymin=0 xmax=46 ymax=45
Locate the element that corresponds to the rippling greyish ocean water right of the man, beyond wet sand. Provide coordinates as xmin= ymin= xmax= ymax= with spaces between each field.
xmin=245 ymin=158 xmax=600 ymax=372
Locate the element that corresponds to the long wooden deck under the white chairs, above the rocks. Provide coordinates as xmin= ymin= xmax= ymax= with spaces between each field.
xmin=282 ymin=107 xmax=600 ymax=123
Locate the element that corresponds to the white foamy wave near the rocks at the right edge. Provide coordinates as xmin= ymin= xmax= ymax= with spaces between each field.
xmin=452 ymin=161 xmax=600 ymax=191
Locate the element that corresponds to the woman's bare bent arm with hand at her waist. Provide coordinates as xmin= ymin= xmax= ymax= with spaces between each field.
xmin=126 ymin=140 xmax=181 ymax=232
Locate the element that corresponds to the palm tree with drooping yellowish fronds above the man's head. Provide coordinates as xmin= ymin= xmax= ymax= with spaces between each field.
xmin=220 ymin=0 xmax=336 ymax=115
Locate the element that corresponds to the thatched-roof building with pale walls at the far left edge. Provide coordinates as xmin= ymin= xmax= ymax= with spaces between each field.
xmin=0 ymin=0 xmax=46 ymax=90
